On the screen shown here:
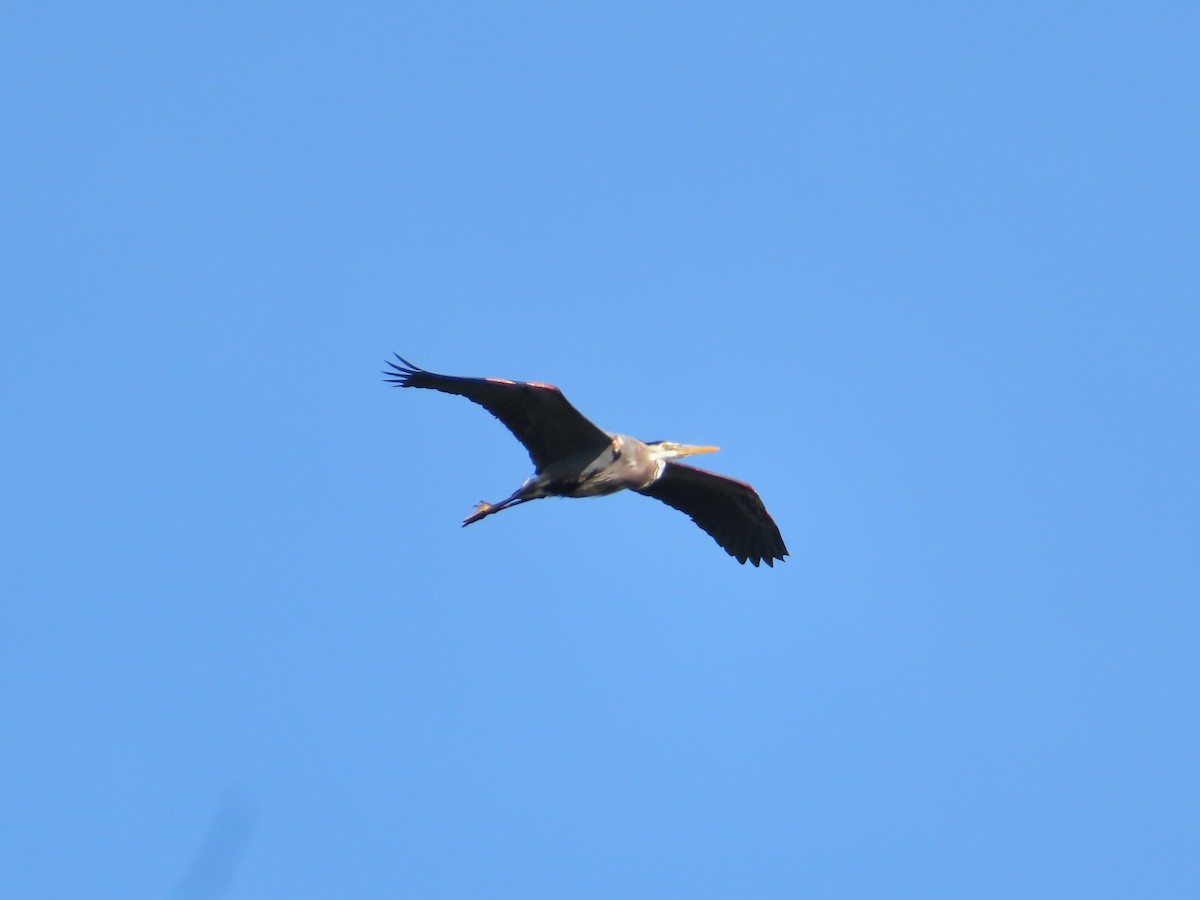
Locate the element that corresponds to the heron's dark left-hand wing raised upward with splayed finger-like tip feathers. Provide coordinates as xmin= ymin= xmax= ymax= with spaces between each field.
xmin=384 ymin=354 xmax=612 ymax=470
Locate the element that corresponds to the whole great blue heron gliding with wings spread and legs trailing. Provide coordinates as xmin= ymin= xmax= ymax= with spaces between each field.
xmin=384 ymin=354 xmax=787 ymax=565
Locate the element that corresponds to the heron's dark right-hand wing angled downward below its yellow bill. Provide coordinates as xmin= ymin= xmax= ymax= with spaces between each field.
xmin=638 ymin=462 xmax=787 ymax=565
